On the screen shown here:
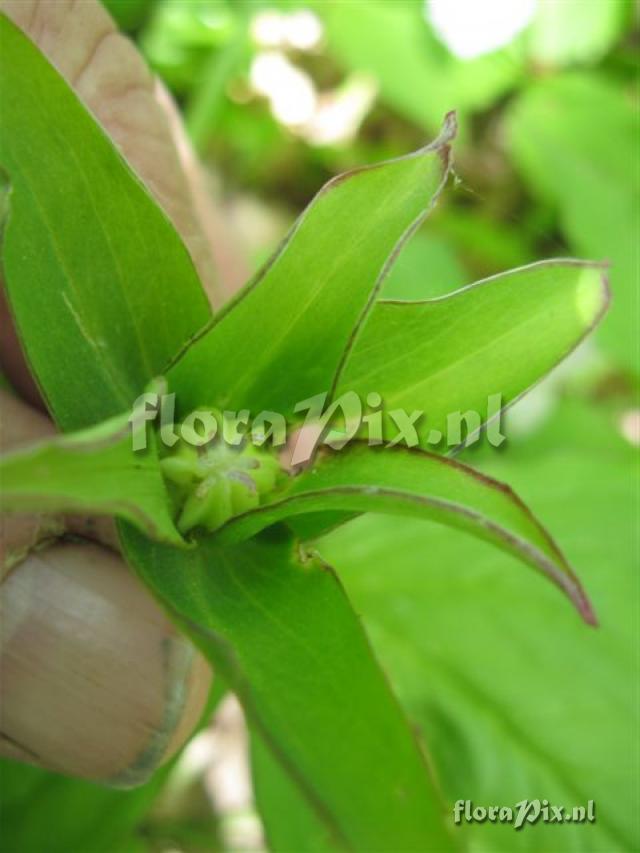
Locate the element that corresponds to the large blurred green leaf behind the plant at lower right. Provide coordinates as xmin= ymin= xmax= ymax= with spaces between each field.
xmin=318 ymin=406 xmax=640 ymax=853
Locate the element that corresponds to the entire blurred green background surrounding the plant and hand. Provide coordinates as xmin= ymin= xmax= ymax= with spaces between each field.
xmin=0 ymin=0 xmax=640 ymax=853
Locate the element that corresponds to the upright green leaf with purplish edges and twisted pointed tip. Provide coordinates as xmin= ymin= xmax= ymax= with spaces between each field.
xmin=168 ymin=115 xmax=455 ymax=415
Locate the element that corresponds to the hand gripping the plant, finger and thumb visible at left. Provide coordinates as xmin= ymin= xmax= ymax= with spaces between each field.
xmin=0 ymin=0 xmax=244 ymax=785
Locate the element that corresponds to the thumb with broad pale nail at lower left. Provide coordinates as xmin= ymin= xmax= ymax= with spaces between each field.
xmin=0 ymin=544 xmax=211 ymax=786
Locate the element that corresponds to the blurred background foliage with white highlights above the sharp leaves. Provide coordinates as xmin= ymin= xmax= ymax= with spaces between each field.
xmin=112 ymin=0 xmax=640 ymax=369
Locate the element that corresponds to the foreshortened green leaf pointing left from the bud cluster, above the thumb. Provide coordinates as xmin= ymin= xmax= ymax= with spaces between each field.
xmin=0 ymin=406 xmax=185 ymax=546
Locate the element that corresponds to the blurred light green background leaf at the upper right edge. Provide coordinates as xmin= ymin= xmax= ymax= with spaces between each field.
xmin=507 ymin=74 xmax=640 ymax=371
